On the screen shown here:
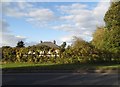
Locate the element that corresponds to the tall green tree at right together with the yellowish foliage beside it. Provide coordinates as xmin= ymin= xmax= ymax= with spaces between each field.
xmin=92 ymin=1 xmax=120 ymax=53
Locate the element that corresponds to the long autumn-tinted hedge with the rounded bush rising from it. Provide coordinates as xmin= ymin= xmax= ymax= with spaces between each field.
xmin=2 ymin=35 xmax=120 ymax=64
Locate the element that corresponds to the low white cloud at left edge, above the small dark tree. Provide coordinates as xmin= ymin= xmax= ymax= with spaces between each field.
xmin=0 ymin=20 xmax=26 ymax=47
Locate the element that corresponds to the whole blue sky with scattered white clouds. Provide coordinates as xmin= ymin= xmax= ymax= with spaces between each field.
xmin=0 ymin=0 xmax=110 ymax=47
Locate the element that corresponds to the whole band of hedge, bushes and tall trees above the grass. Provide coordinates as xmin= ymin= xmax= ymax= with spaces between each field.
xmin=2 ymin=1 xmax=120 ymax=64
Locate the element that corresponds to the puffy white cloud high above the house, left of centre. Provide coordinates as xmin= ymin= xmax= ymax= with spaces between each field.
xmin=27 ymin=9 xmax=55 ymax=22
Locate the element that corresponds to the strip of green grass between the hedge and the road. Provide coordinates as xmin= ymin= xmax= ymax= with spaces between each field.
xmin=1 ymin=63 xmax=120 ymax=70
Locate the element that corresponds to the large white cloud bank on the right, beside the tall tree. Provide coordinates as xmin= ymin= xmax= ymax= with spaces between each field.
xmin=55 ymin=1 xmax=110 ymax=42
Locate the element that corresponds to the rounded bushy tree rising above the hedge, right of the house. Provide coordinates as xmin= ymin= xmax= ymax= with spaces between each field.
xmin=70 ymin=37 xmax=94 ymax=62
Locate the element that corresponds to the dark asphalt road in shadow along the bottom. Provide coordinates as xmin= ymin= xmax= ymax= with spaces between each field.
xmin=2 ymin=73 xmax=120 ymax=85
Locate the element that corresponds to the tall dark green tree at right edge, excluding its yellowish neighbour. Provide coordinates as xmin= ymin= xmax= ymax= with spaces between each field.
xmin=104 ymin=1 xmax=120 ymax=52
